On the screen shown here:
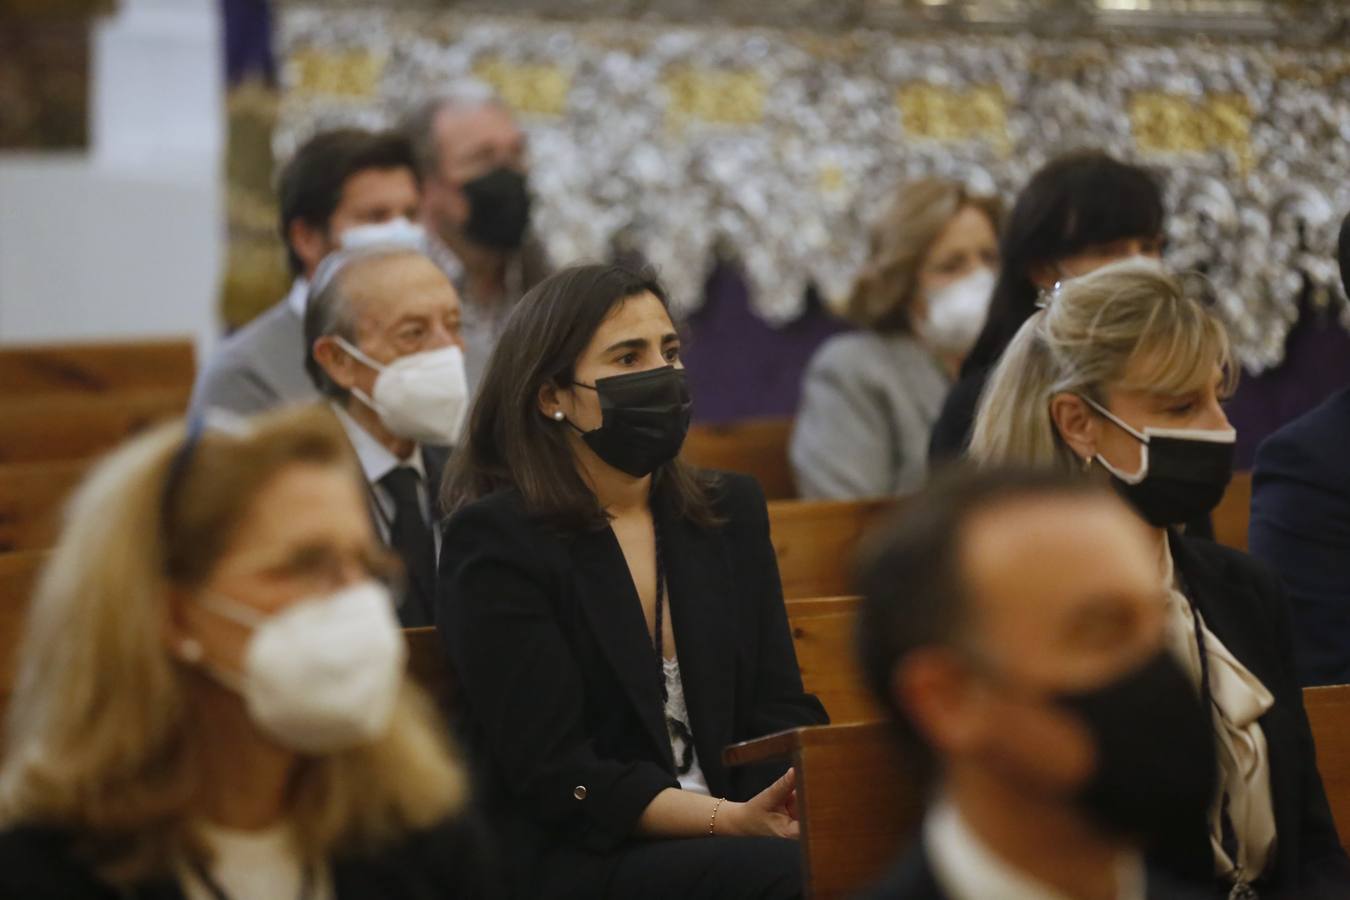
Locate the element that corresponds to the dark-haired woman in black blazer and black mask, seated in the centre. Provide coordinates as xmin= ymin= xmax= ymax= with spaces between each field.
xmin=437 ymin=266 xmax=826 ymax=900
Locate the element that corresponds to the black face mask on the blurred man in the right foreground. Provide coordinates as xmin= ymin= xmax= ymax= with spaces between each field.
xmin=1054 ymin=650 xmax=1218 ymax=849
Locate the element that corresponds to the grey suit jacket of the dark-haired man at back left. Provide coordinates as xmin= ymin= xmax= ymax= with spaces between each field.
xmin=192 ymin=300 xmax=319 ymax=416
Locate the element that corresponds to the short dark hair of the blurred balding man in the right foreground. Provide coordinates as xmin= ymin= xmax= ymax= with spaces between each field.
xmin=855 ymin=467 xmax=1110 ymax=748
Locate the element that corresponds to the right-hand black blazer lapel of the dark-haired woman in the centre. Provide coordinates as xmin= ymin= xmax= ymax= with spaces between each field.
xmin=656 ymin=503 xmax=737 ymax=793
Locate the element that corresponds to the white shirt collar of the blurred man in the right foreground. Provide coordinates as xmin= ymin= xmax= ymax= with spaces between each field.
xmin=923 ymin=800 xmax=1145 ymax=900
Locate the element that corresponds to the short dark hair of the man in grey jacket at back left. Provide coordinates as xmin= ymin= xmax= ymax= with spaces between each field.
xmin=277 ymin=128 xmax=417 ymax=275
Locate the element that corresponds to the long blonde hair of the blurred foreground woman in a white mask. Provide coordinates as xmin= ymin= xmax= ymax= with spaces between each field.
xmin=0 ymin=409 xmax=466 ymax=882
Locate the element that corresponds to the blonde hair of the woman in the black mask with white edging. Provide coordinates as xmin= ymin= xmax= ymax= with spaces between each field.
xmin=969 ymin=259 xmax=1237 ymax=471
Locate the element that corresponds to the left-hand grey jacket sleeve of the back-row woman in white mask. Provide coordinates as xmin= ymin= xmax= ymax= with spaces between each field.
xmin=788 ymin=341 xmax=900 ymax=499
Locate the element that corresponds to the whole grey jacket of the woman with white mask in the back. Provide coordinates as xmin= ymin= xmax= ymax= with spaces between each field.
xmin=788 ymin=332 xmax=950 ymax=499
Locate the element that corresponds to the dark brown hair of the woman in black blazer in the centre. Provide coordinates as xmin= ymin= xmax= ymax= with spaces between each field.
xmin=441 ymin=264 xmax=718 ymax=532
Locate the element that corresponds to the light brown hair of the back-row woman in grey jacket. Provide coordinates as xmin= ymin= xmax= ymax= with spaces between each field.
xmin=842 ymin=178 xmax=1003 ymax=332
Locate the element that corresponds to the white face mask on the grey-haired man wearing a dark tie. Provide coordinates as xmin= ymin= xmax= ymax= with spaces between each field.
xmin=336 ymin=337 xmax=468 ymax=447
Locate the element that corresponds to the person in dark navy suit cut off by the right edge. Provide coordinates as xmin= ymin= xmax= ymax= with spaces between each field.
xmin=1249 ymin=216 xmax=1350 ymax=685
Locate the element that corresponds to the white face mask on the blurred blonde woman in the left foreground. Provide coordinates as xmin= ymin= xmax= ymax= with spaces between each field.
xmin=197 ymin=582 xmax=408 ymax=753
